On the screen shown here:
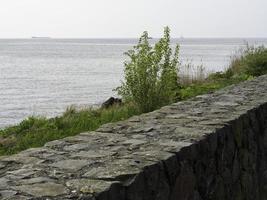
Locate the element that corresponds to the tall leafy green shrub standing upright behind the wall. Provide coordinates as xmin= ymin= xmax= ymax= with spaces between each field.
xmin=116 ymin=27 xmax=179 ymax=112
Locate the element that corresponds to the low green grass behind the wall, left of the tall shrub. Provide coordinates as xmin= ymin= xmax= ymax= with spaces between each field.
xmin=0 ymin=104 xmax=140 ymax=155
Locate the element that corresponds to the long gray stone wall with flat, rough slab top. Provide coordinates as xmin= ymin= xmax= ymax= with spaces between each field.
xmin=0 ymin=76 xmax=267 ymax=200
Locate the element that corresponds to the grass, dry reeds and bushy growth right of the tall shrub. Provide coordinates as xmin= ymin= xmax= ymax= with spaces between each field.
xmin=180 ymin=45 xmax=267 ymax=100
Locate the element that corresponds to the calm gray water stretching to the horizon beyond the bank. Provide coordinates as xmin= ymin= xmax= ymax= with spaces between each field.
xmin=0 ymin=39 xmax=267 ymax=127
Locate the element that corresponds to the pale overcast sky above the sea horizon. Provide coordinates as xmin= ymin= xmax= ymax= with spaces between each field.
xmin=0 ymin=0 xmax=267 ymax=38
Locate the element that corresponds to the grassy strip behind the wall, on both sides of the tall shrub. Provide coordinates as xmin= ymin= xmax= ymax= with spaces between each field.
xmin=0 ymin=47 xmax=267 ymax=155
